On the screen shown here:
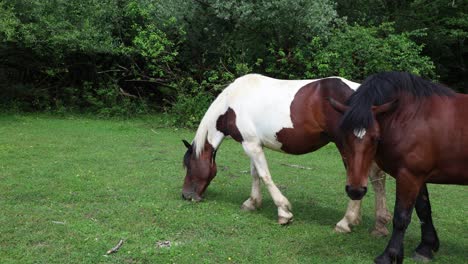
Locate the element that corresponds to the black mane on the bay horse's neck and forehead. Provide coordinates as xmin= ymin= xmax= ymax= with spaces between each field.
xmin=340 ymin=72 xmax=455 ymax=132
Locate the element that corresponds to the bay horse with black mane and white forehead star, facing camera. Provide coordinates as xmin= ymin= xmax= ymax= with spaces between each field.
xmin=330 ymin=72 xmax=468 ymax=263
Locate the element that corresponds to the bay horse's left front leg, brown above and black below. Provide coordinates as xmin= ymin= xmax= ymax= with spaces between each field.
xmin=375 ymin=170 xmax=423 ymax=264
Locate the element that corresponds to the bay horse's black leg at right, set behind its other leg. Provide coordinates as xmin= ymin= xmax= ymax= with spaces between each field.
xmin=414 ymin=184 xmax=439 ymax=262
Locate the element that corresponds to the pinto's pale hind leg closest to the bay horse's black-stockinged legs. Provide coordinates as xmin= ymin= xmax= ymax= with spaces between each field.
xmin=369 ymin=163 xmax=392 ymax=237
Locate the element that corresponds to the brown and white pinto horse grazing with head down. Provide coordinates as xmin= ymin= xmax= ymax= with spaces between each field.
xmin=182 ymin=74 xmax=391 ymax=235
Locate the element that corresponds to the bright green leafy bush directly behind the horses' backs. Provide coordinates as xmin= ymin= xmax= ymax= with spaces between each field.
xmin=267 ymin=24 xmax=435 ymax=80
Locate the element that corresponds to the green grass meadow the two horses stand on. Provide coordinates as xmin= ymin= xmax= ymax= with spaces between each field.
xmin=0 ymin=114 xmax=468 ymax=263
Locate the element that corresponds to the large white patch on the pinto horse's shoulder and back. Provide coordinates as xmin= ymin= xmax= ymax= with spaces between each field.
xmin=224 ymin=74 xmax=314 ymax=150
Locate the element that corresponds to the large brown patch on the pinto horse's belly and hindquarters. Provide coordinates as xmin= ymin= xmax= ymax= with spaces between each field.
xmin=276 ymin=78 xmax=353 ymax=154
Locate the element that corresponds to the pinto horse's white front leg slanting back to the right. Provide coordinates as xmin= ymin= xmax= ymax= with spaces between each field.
xmin=242 ymin=141 xmax=293 ymax=225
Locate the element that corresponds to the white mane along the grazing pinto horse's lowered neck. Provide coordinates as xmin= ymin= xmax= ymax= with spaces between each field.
xmin=193 ymin=86 xmax=227 ymax=157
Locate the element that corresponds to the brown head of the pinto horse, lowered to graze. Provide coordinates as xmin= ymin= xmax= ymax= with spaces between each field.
xmin=182 ymin=140 xmax=216 ymax=201
